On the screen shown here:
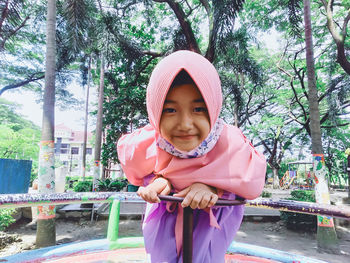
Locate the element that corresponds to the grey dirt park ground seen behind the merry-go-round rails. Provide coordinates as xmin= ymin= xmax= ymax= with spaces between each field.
xmin=0 ymin=191 xmax=350 ymax=263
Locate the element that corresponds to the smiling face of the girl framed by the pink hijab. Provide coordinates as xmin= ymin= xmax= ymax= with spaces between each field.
xmin=159 ymin=84 xmax=210 ymax=152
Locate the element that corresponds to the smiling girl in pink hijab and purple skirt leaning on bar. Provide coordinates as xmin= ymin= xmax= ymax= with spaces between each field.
xmin=117 ymin=51 xmax=266 ymax=263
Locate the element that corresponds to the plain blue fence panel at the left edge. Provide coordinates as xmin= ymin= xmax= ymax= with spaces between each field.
xmin=0 ymin=159 xmax=32 ymax=194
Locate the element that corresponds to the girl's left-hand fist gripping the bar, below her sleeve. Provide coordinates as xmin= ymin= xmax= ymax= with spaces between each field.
xmin=137 ymin=177 xmax=171 ymax=203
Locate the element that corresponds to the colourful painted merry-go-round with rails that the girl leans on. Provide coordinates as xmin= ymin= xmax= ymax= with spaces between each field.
xmin=0 ymin=192 xmax=350 ymax=263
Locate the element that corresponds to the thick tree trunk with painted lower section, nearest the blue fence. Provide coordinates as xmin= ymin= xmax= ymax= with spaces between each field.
xmin=36 ymin=0 xmax=56 ymax=248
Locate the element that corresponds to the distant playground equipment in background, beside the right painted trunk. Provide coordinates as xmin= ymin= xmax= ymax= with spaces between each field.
xmin=280 ymin=161 xmax=314 ymax=189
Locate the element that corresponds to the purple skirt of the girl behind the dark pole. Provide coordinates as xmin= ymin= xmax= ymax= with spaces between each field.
xmin=142 ymin=193 xmax=244 ymax=263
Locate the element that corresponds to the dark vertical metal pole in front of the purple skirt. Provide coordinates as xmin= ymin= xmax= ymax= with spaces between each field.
xmin=182 ymin=206 xmax=193 ymax=263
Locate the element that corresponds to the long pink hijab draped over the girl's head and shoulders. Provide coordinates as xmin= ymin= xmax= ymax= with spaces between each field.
xmin=117 ymin=51 xmax=266 ymax=199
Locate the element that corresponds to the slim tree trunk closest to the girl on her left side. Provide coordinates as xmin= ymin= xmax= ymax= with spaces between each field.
xmin=93 ymin=55 xmax=105 ymax=191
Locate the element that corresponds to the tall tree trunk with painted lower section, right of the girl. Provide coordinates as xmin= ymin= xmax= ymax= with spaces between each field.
xmin=304 ymin=0 xmax=339 ymax=253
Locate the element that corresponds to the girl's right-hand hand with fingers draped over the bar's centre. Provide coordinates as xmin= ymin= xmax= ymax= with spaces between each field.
xmin=174 ymin=183 xmax=219 ymax=209
